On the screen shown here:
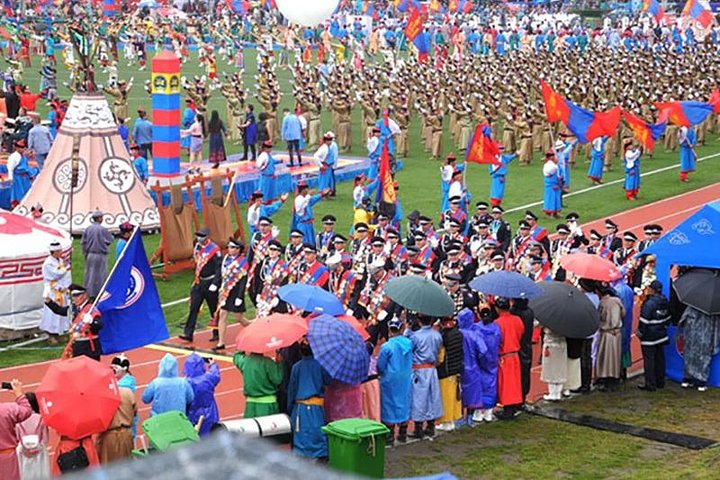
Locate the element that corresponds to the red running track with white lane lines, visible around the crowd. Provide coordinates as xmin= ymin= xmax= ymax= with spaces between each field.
xmin=0 ymin=184 xmax=720 ymax=444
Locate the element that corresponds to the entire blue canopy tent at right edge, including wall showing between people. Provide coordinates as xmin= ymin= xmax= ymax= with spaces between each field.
xmin=642 ymin=200 xmax=720 ymax=387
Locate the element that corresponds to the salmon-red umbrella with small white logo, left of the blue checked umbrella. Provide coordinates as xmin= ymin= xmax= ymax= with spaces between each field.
xmin=235 ymin=313 xmax=308 ymax=353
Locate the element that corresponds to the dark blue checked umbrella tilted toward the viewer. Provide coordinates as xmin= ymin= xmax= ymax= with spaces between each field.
xmin=307 ymin=315 xmax=370 ymax=385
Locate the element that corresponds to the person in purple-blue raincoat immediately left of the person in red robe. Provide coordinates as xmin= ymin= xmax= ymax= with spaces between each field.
xmin=473 ymin=308 xmax=502 ymax=422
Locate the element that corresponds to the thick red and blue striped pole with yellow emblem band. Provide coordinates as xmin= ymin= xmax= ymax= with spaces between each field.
xmin=150 ymin=50 xmax=180 ymax=176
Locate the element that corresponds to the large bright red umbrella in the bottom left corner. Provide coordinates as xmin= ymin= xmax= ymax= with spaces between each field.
xmin=35 ymin=356 xmax=120 ymax=440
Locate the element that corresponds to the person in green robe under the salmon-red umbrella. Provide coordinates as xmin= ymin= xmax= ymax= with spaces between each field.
xmin=233 ymin=352 xmax=283 ymax=418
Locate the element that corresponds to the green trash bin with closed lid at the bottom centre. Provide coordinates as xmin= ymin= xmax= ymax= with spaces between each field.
xmin=322 ymin=418 xmax=390 ymax=478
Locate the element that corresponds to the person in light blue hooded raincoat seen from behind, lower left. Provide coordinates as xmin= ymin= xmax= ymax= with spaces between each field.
xmin=142 ymin=353 xmax=195 ymax=416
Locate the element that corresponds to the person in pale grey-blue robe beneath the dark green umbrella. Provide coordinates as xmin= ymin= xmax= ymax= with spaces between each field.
xmin=405 ymin=314 xmax=443 ymax=440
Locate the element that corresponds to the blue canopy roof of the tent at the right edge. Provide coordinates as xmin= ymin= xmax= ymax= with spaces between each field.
xmin=642 ymin=200 xmax=720 ymax=296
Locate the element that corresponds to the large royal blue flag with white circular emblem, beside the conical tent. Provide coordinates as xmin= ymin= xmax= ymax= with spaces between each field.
xmin=97 ymin=230 xmax=170 ymax=354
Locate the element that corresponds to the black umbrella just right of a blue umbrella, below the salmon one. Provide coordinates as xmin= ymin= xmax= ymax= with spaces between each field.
xmin=530 ymin=282 xmax=600 ymax=338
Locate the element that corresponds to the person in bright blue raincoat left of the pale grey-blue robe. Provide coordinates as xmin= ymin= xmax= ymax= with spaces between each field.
xmin=377 ymin=317 xmax=413 ymax=443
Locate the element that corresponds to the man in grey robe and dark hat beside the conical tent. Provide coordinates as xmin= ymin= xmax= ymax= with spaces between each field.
xmin=80 ymin=210 xmax=113 ymax=298
